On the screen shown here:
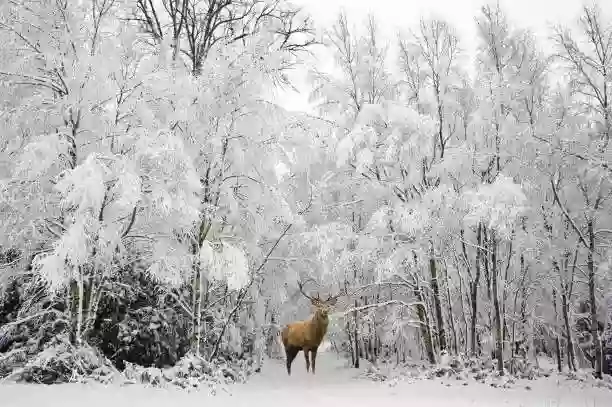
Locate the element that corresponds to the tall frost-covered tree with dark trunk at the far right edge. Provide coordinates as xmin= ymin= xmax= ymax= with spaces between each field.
xmin=550 ymin=6 xmax=612 ymax=378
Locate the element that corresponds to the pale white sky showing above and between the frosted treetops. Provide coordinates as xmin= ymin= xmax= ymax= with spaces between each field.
xmin=276 ymin=0 xmax=612 ymax=110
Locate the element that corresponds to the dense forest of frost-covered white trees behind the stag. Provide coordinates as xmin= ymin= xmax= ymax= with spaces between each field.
xmin=0 ymin=0 xmax=612 ymax=387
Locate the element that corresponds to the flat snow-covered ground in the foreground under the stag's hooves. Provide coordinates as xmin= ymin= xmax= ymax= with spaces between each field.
xmin=0 ymin=353 xmax=612 ymax=407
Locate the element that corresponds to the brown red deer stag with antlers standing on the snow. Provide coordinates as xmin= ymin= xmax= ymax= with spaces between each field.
xmin=281 ymin=282 xmax=343 ymax=376
